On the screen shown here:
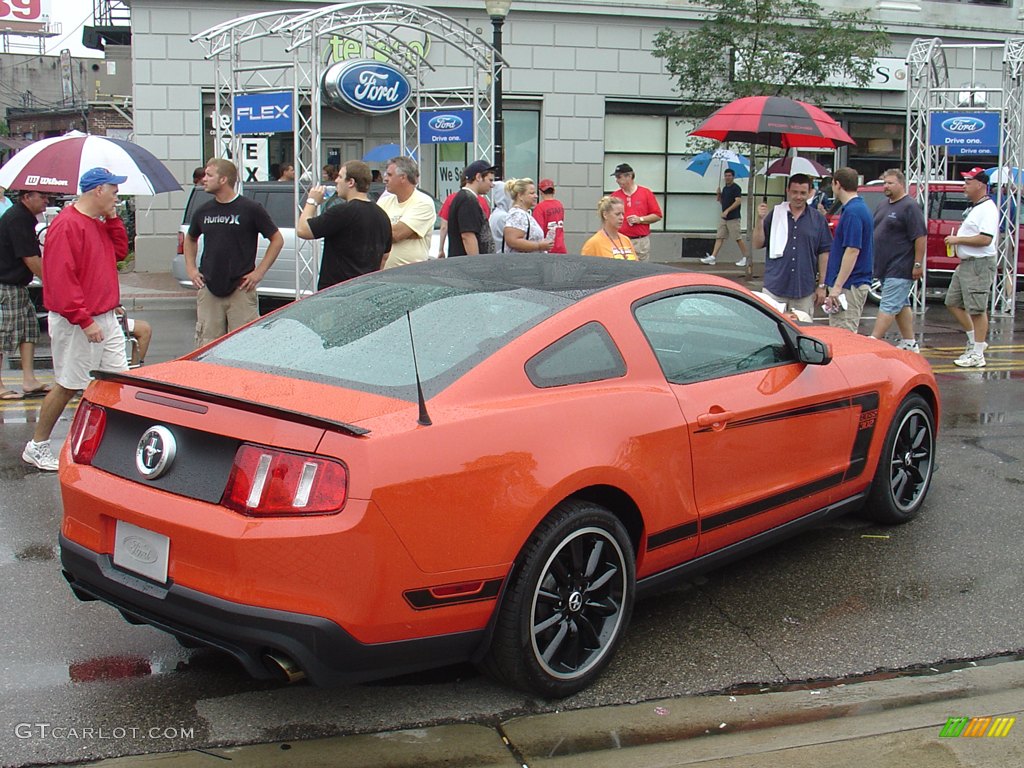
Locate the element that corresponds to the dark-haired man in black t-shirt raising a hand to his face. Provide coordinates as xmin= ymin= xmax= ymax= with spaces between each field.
xmin=295 ymin=160 xmax=391 ymax=290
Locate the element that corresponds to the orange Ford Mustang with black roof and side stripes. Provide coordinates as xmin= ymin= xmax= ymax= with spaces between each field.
xmin=54 ymin=254 xmax=939 ymax=697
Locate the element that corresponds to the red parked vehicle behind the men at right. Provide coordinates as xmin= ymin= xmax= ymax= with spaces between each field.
xmin=827 ymin=181 xmax=1024 ymax=303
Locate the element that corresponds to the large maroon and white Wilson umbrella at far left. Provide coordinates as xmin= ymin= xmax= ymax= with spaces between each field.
xmin=0 ymin=131 xmax=181 ymax=195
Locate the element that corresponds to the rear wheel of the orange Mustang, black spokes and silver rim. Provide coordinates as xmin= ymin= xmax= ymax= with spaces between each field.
xmin=481 ymin=501 xmax=636 ymax=698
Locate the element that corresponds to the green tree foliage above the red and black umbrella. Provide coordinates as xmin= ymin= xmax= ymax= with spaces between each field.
xmin=654 ymin=0 xmax=890 ymax=104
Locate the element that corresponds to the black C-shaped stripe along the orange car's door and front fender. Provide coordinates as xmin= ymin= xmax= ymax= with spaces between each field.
xmin=647 ymin=392 xmax=879 ymax=551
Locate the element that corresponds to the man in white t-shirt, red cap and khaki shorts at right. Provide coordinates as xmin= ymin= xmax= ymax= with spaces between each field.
xmin=946 ymin=168 xmax=999 ymax=368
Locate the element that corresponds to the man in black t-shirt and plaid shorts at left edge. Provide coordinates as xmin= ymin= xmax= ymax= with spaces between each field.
xmin=0 ymin=190 xmax=46 ymax=400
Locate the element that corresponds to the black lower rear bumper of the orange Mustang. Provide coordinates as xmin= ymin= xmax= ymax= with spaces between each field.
xmin=59 ymin=535 xmax=484 ymax=685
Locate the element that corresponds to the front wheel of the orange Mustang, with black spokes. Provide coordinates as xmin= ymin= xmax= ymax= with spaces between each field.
xmin=864 ymin=394 xmax=935 ymax=525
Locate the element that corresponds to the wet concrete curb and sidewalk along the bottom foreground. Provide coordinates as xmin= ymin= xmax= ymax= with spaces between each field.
xmin=79 ymin=662 xmax=1024 ymax=768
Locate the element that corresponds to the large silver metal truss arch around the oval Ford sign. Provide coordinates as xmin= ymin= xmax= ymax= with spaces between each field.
xmin=191 ymin=1 xmax=508 ymax=298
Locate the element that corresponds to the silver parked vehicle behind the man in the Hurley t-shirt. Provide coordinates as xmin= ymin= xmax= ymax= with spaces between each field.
xmin=171 ymin=181 xmax=440 ymax=299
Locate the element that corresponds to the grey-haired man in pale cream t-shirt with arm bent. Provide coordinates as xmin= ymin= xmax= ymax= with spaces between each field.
xmin=377 ymin=157 xmax=437 ymax=269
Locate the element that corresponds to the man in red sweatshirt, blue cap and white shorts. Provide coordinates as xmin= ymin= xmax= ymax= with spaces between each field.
xmin=22 ymin=168 xmax=128 ymax=472
